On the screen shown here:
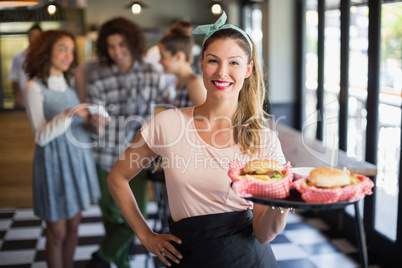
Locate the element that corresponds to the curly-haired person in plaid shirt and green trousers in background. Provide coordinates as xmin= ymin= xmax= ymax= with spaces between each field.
xmin=87 ymin=17 xmax=175 ymax=268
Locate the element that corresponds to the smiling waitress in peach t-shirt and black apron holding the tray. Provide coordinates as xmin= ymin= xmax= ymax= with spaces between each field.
xmin=108 ymin=13 xmax=288 ymax=268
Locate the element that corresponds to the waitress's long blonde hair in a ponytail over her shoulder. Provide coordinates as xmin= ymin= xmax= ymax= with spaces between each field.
xmin=202 ymin=29 xmax=268 ymax=156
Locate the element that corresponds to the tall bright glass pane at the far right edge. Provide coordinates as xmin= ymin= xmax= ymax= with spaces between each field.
xmin=375 ymin=2 xmax=402 ymax=241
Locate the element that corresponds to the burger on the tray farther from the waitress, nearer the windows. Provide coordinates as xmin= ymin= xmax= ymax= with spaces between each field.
xmin=307 ymin=167 xmax=356 ymax=188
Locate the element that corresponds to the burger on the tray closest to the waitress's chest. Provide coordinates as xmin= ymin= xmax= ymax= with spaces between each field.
xmin=240 ymin=159 xmax=286 ymax=181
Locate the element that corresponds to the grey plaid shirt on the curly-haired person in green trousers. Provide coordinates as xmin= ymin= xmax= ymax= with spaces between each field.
xmin=87 ymin=61 xmax=175 ymax=172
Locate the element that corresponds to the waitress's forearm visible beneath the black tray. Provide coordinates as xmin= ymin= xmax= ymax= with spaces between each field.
xmin=253 ymin=203 xmax=288 ymax=244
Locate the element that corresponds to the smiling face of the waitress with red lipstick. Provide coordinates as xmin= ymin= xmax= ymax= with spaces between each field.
xmin=201 ymin=38 xmax=253 ymax=101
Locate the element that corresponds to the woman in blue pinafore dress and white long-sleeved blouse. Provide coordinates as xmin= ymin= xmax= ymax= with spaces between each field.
xmin=24 ymin=30 xmax=100 ymax=268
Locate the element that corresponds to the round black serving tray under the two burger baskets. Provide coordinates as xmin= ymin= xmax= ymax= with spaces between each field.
xmin=246 ymin=189 xmax=359 ymax=210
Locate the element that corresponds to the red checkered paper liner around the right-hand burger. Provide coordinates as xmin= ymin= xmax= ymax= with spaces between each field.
xmin=292 ymin=175 xmax=374 ymax=203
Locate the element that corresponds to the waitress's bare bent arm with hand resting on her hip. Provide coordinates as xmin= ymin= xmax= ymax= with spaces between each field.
xmin=107 ymin=133 xmax=182 ymax=266
